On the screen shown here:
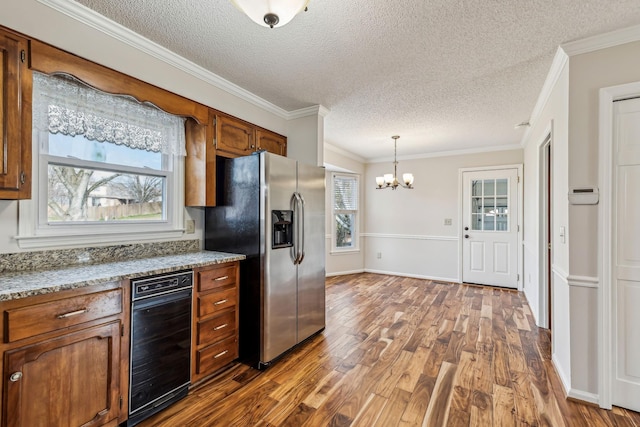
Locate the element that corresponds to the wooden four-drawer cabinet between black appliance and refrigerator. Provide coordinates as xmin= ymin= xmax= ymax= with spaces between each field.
xmin=191 ymin=261 xmax=240 ymax=384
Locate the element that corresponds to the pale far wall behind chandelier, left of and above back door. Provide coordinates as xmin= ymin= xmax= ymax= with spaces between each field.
xmin=363 ymin=149 xmax=523 ymax=282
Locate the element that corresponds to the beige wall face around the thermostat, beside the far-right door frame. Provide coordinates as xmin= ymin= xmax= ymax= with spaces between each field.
xmin=568 ymin=42 xmax=640 ymax=393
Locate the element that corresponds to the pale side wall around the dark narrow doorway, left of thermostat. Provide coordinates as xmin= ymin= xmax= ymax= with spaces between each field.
xmin=523 ymin=53 xmax=572 ymax=394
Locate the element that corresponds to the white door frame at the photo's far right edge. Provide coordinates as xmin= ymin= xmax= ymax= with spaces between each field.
xmin=598 ymin=82 xmax=640 ymax=409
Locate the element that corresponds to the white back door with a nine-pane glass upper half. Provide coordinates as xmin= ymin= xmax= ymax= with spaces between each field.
xmin=462 ymin=168 xmax=518 ymax=288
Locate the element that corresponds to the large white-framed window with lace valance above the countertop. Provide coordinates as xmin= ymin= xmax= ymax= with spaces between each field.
xmin=18 ymin=72 xmax=185 ymax=247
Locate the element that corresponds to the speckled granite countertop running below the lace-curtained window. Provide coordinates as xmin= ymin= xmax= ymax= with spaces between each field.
xmin=0 ymin=251 xmax=246 ymax=301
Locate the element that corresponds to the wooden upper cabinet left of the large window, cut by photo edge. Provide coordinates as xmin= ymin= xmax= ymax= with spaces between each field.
xmin=0 ymin=29 xmax=32 ymax=199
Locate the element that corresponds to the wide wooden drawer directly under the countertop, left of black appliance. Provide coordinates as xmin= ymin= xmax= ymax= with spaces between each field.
xmin=5 ymin=289 xmax=122 ymax=342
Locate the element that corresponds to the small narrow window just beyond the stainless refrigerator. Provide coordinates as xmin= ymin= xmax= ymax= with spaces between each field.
xmin=332 ymin=173 xmax=359 ymax=251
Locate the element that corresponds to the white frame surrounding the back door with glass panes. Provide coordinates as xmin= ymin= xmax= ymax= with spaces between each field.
xmin=458 ymin=163 xmax=524 ymax=291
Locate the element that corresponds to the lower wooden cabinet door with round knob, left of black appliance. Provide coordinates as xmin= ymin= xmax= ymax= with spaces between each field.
xmin=3 ymin=321 xmax=120 ymax=427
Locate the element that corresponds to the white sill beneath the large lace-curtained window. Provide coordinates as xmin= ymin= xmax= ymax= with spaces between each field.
xmin=14 ymin=229 xmax=184 ymax=249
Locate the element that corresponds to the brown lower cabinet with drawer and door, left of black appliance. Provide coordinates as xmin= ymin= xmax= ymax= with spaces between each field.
xmin=0 ymin=283 xmax=129 ymax=426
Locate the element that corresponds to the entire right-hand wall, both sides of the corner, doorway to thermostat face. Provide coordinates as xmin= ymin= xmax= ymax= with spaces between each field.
xmin=524 ymin=38 xmax=640 ymax=403
